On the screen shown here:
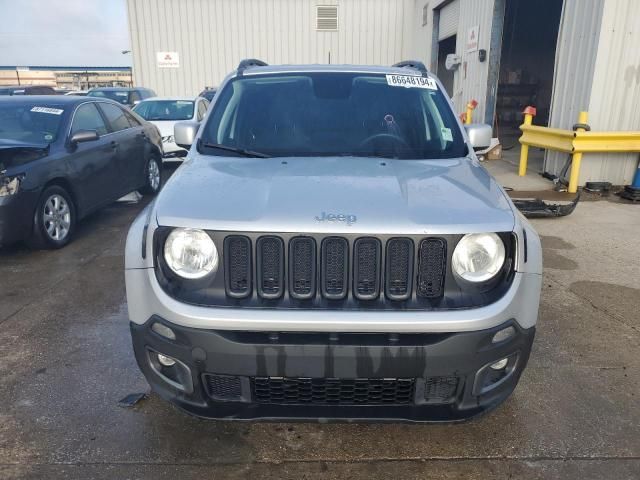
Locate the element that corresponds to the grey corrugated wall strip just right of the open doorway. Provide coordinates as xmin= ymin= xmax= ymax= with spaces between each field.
xmin=534 ymin=0 xmax=605 ymax=175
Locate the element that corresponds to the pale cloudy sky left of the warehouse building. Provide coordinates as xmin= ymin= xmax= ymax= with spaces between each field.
xmin=0 ymin=0 xmax=131 ymax=67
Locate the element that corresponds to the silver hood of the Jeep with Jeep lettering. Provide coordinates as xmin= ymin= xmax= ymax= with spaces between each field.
xmin=156 ymin=154 xmax=514 ymax=234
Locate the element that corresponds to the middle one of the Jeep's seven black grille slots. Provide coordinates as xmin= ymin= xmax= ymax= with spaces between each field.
xmin=321 ymin=237 xmax=349 ymax=300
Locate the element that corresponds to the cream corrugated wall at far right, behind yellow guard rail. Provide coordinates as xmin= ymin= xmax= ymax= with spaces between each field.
xmin=580 ymin=0 xmax=640 ymax=185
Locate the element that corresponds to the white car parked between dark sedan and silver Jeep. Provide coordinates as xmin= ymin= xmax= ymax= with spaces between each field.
xmin=133 ymin=97 xmax=209 ymax=160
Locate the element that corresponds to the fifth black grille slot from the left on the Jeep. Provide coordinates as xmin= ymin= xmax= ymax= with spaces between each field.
xmin=353 ymin=237 xmax=380 ymax=300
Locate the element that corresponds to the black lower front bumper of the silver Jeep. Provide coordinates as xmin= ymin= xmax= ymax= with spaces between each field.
xmin=131 ymin=316 xmax=535 ymax=422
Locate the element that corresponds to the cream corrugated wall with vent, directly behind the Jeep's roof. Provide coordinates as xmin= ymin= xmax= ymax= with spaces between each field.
xmin=127 ymin=0 xmax=415 ymax=95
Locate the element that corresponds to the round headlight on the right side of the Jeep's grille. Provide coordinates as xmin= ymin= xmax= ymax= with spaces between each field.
xmin=452 ymin=233 xmax=505 ymax=283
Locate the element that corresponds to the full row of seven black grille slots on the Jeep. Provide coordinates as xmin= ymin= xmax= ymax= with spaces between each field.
xmin=224 ymin=235 xmax=447 ymax=302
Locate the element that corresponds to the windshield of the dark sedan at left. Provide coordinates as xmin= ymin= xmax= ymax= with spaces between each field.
xmin=0 ymin=102 xmax=64 ymax=144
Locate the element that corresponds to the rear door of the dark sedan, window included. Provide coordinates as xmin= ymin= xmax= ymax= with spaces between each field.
xmin=99 ymin=102 xmax=147 ymax=195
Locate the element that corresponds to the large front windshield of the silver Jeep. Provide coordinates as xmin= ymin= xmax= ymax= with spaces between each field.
xmin=199 ymin=72 xmax=466 ymax=159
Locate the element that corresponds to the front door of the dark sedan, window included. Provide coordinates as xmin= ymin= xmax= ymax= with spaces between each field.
xmin=67 ymin=102 xmax=118 ymax=211
